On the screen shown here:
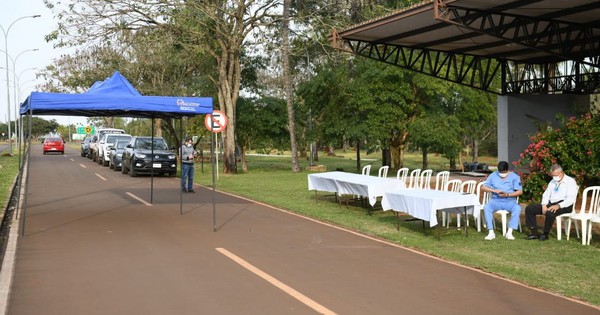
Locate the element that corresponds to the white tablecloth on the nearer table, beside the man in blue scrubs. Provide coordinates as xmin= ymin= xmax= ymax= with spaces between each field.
xmin=381 ymin=189 xmax=481 ymax=226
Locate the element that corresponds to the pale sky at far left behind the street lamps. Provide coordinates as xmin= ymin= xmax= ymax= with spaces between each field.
xmin=0 ymin=0 xmax=86 ymax=125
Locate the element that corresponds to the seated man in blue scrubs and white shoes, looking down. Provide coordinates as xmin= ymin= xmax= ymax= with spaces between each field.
xmin=481 ymin=161 xmax=523 ymax=241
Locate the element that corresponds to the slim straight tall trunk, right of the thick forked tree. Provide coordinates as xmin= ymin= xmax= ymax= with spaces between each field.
xmin=281 ymin=0 xmax=300 ymax=173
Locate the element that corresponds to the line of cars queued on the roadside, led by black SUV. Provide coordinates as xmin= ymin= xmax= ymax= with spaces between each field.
xmin=76 ymin=128 xmax=177 ymax=177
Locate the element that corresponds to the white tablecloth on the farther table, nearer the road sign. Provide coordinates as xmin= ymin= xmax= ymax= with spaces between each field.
xmin=308 ymin=172 xmax=406 ymax=206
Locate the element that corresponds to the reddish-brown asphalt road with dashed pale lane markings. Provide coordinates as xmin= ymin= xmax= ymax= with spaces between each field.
xmin=7 ymin=145 xmax=600 ymax=315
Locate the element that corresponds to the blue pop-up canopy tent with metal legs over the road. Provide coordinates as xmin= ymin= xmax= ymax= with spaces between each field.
xmin=19 ymin=71 xmax=214 ymax=233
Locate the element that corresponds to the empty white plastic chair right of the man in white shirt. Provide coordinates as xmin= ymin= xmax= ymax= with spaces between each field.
xmin=567 ymin=186 xmax=600 ymax=245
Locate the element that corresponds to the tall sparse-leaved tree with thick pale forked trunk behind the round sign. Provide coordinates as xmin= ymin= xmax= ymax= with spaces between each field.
xmin=46 ymin=0 xmax=277 ymax=173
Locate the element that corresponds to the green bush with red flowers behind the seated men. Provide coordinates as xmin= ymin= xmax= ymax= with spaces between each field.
xmin=514 ymin=114 xmax=600 ymax=202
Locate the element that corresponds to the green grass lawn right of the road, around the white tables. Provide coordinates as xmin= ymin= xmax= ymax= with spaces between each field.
xmin=195 ymin=153 xmax=600 ymax=305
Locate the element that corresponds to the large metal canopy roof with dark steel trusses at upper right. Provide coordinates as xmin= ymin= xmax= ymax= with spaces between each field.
xmin=333 ymin=0 xmax=600 ymax=94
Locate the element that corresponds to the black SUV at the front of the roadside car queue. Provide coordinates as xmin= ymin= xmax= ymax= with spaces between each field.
xmin=121 ymin=137 xmax=177 ymax=177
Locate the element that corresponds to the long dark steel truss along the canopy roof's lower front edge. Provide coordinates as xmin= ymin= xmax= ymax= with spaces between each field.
xmin=334 ymin=34 xmax=600 ymax=95
